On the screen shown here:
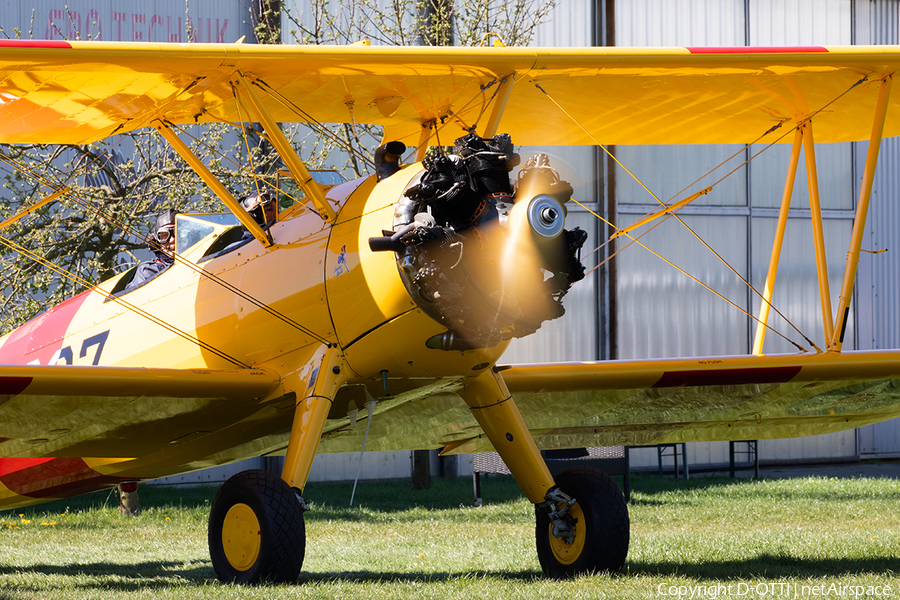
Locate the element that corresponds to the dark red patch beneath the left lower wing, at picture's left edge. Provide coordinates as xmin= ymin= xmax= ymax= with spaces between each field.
xmin=0 ymin=458 xmax=121 ymax=498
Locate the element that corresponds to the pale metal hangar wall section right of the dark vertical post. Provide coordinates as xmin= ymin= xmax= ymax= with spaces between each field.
xmin=616 ymin=0 xmax=856 ymax=466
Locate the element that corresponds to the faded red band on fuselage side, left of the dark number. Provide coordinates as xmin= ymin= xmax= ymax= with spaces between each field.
xmin=0 ymin=290 xmax=91 ymax=365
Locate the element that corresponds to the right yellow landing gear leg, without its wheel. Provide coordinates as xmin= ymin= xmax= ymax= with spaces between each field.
xmin=459 ymin=369 xmax=555 ymax=504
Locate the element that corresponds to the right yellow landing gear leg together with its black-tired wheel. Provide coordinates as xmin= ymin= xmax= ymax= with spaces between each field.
xmin=460 ymin=371 xmax=629 ymax=578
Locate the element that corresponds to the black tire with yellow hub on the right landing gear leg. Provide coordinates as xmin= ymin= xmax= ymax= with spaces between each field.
xmin=535 ymin=467 xmax=631 ymax=579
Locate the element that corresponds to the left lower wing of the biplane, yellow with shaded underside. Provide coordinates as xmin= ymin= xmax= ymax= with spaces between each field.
xmin=0 ymin=365 xmax=282 ymax=507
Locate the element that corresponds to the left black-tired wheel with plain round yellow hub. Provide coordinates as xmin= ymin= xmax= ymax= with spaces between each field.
xmin=209 ymin=470 xmax=306 ymax=583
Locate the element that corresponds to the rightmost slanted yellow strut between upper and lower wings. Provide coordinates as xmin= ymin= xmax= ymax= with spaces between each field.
xmin=831 ymin=77 xmax=893 ymax=352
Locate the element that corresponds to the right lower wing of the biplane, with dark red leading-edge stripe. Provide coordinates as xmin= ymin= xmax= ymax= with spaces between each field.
xmin=312 ymin=352 xmax=900 ymax=453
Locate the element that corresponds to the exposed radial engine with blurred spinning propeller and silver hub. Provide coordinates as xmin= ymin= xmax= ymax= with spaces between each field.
xmin=369 ymin=133 xmax=587 ymax=350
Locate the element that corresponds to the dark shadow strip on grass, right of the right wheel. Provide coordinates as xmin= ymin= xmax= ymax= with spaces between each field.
xmin=626 ymin=554 xmax=900 ymax=580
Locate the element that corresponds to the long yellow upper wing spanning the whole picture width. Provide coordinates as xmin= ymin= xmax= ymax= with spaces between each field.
xmin=0 ymin=40 xmax=900 ymax=145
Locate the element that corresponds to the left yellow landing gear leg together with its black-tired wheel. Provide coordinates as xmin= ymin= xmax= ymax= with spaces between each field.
xmin=209 ymin=346 xmax=346 ymax=583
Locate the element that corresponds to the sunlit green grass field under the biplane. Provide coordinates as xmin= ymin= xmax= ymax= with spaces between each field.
xmin=0 ymin=476 xmax=900 ymax=600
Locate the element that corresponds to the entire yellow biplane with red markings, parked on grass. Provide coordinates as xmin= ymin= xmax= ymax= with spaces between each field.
xmin=0 ymin=41 xmax=900 ymax=582
